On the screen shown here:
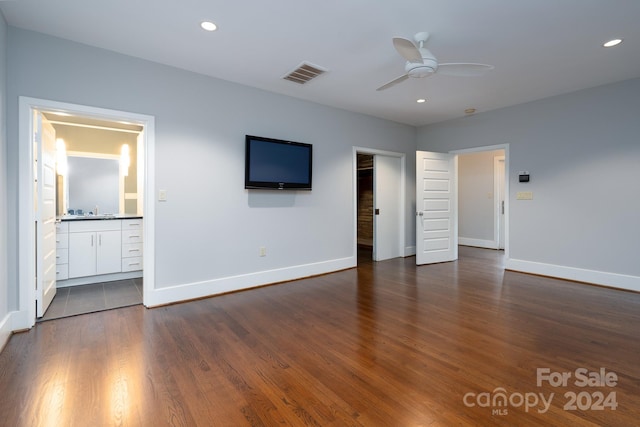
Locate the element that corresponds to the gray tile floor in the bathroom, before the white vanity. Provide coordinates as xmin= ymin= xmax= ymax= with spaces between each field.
xmin=38 ymin=278 xmax=142 ymax=322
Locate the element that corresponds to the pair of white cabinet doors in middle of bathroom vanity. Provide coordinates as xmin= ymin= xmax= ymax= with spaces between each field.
xmin=69 ymin=220 xmax=122 ymax=279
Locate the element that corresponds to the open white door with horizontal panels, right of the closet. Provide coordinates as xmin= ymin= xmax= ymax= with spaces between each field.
xmin=416 ymin=151 xmax=458 ymax=265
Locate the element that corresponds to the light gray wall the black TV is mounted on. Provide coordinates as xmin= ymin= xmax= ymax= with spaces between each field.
xmin=8 ymin=27 xmax=416 ymax=305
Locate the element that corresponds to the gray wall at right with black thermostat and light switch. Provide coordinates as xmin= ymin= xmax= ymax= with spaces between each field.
xmin=417 ymin=79 xmax=640 ymax=280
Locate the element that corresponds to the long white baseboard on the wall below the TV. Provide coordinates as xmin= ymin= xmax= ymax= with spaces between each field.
xmin=144 ymin=256 xmax=357 ymax=307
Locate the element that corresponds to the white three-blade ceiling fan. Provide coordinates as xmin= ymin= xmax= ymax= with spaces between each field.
xmin=376 ymin=32 xmax=493 ymax=90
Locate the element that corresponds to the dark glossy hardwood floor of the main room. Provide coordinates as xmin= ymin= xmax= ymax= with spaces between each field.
xmin=0 ymin=247 xmax=640 ymax=427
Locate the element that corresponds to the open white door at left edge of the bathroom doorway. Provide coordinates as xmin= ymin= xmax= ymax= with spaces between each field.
xmin=34 ymin=112 xmax=56 ymax=317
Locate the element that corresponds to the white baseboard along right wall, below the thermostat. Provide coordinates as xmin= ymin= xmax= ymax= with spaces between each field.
xmin=505 ymin=259 xmax=640 ymax=292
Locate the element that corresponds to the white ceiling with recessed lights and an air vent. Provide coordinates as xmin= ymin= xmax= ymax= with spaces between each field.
xmin=0 ymin=0 xmax=640 ymax=126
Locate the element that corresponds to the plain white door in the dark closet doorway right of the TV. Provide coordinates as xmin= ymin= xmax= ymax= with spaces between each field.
xmin=373 ymin=154 xmax=404 ymax=261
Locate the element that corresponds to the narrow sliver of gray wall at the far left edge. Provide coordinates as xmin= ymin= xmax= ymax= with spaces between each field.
xmin=0 ymin=13 xmax=9 ymax=332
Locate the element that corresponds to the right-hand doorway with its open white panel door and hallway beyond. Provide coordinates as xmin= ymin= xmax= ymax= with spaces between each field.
xmin=416 ymin=144 xmax=509 ymax=265
